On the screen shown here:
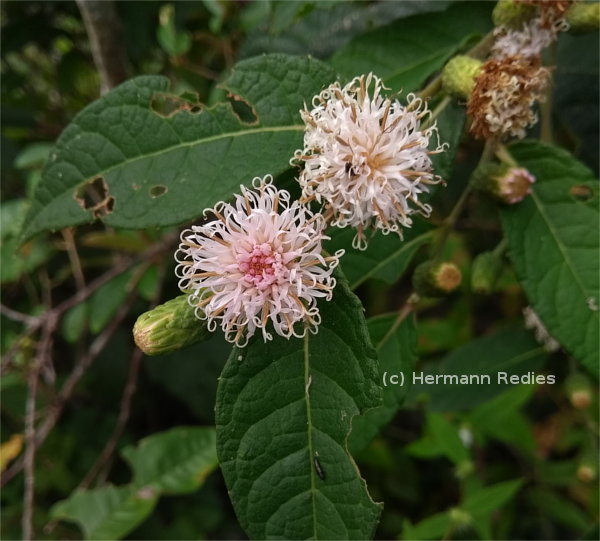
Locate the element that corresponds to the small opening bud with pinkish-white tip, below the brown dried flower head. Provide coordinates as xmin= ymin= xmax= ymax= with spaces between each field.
xmin=471 ymin=162 xmax=535 ymax=205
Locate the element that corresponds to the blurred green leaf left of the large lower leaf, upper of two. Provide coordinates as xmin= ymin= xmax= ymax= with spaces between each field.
xmin=121 ymin=427 xmax=217 ymax=494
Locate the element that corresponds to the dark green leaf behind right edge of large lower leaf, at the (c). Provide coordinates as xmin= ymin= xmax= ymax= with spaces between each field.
xmin=348 ymin=315 xmax=417 ymax=455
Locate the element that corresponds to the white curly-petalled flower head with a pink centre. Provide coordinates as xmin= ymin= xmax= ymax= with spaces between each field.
xmin=175 ymin=175 xmax=343 ymax=347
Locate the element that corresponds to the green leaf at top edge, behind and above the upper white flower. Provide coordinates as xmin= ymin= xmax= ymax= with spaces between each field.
xmin=330 ymin=2 xmax=492 ymax=92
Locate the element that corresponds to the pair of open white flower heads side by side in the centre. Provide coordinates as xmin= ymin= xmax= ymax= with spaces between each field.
xmin=175 ymin=74 xmax=443 ymax=347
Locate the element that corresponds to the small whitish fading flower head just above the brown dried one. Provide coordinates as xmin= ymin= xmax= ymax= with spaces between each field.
xmin=492 ymin=17 xmax=568 ymax=59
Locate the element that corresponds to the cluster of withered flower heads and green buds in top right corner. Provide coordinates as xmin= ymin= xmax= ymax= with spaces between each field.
xmin=442 ymin=0 xmax=600 ymax=140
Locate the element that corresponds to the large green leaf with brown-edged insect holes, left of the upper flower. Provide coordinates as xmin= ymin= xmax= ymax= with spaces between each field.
xmin=23 ymin=54 xmax=335 ymax=238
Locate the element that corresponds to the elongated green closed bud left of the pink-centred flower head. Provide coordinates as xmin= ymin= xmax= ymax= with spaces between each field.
xmin=133 ymin=295 xmax=210 ymax=355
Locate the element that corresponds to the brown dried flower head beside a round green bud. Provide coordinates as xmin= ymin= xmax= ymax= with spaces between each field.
xmin=467 ymin=56 xmax=550 ymax=139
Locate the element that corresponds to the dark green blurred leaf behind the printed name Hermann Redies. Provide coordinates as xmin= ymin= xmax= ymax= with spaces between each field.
xmin=411 ymin=326 xmax=548 ymax=411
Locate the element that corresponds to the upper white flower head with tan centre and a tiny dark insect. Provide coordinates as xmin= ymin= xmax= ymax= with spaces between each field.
xmin=292 ymin=74 xmax=444 ymax=249
